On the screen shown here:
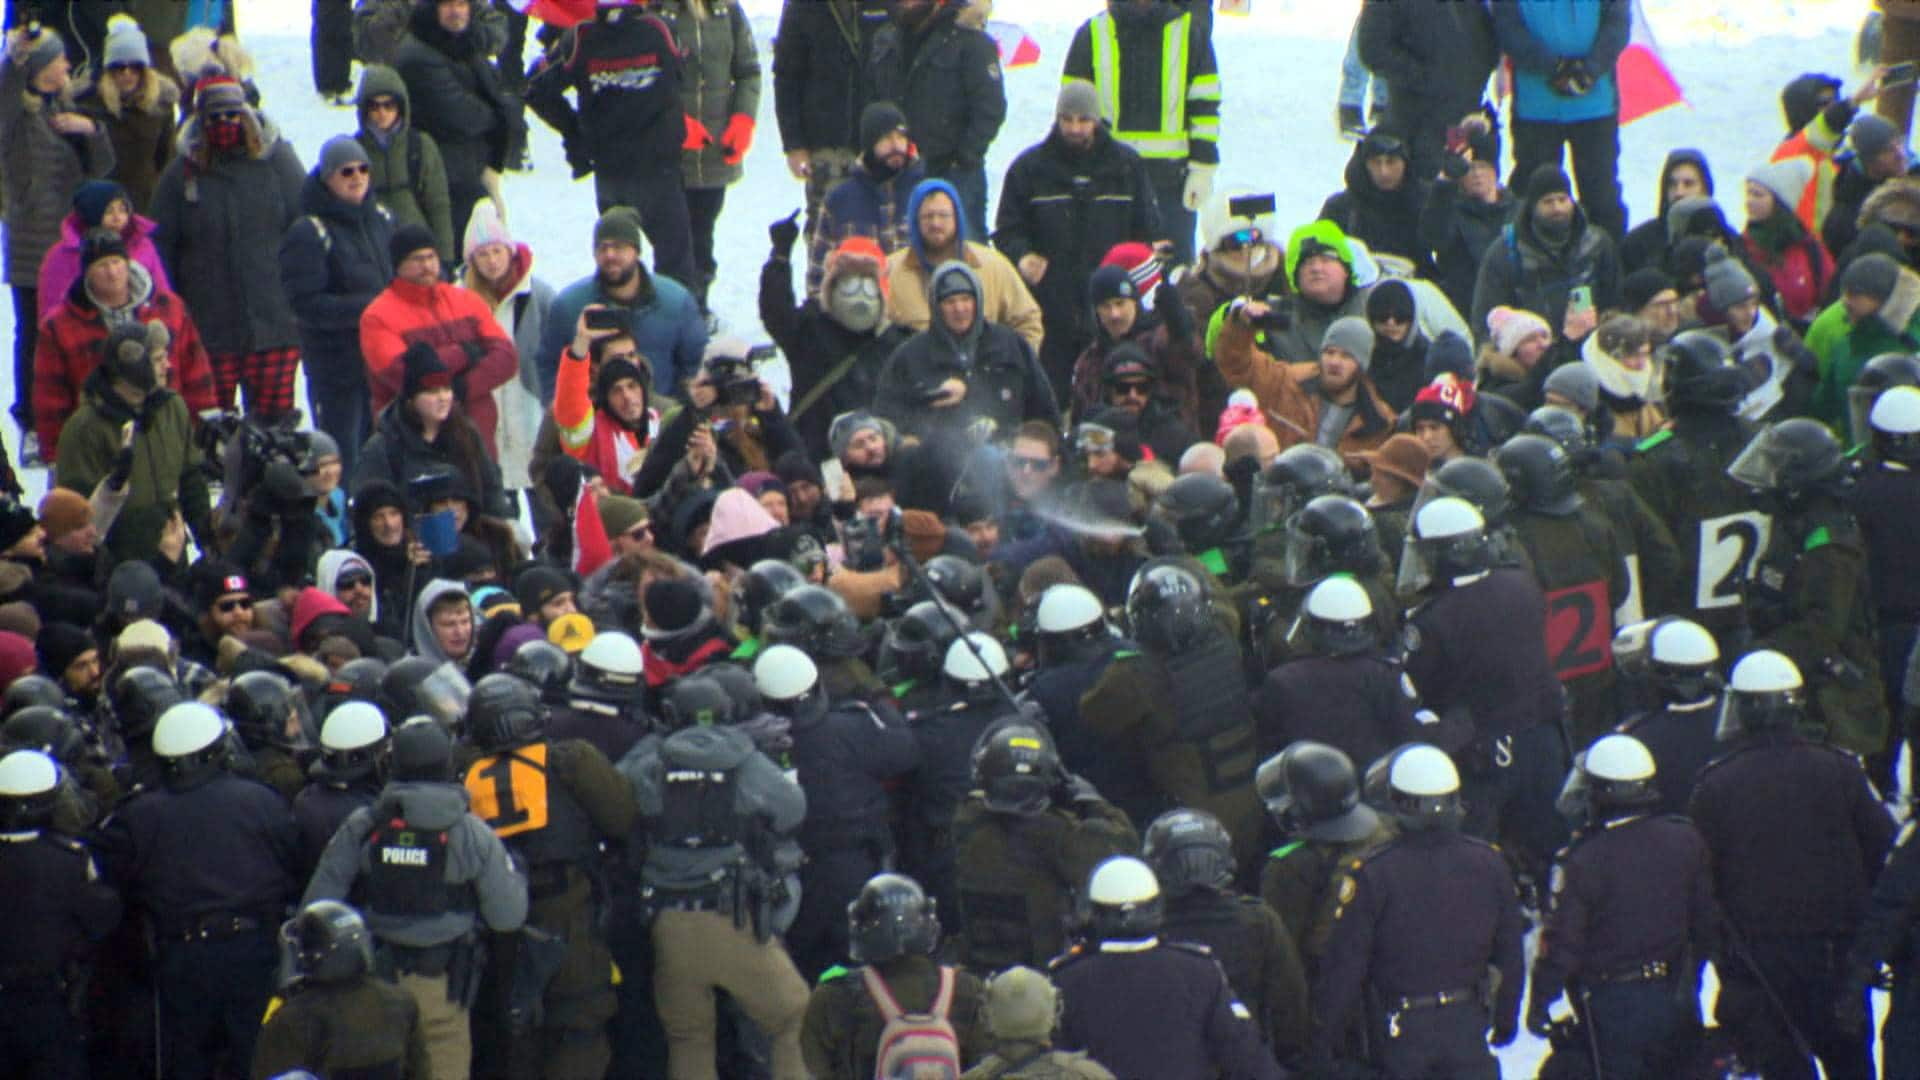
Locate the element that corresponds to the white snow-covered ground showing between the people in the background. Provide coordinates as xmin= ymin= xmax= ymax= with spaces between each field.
xmin=0 ymin=0 xmax=1896 ymax=1076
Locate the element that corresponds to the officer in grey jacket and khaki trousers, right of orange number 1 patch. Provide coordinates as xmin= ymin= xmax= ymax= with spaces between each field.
xmin=622 ymin=664 xmax=808 ymax=1080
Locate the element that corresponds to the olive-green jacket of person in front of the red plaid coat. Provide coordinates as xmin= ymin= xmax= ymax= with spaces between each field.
xmin=54 ymin=369 xmax=213 ymax=563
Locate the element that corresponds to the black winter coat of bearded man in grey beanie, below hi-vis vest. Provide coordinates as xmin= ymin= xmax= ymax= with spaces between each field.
xmin=993 ymin=125 xmax=1160 ymax=340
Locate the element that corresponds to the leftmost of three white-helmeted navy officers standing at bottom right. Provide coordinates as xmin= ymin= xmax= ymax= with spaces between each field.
xmin=1313 ymin=744 xmax=1526 ymax=1080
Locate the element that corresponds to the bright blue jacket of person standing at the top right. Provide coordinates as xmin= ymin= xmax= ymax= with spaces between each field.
xmin=1490 ymin=0 xmax=1632 ymax=123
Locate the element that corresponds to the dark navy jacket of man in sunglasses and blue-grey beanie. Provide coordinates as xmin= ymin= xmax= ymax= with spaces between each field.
xmin=280 ymin=173 xmax=394 ymax=386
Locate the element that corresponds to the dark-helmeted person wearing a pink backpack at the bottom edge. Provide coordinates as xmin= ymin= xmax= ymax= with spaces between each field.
xmin=801 ymin=874 xmax=983 ymax=1080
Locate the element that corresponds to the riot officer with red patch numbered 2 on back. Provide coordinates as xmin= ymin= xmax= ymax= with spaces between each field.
xmin=1494 ymin=434 xmax=1632 ymax=748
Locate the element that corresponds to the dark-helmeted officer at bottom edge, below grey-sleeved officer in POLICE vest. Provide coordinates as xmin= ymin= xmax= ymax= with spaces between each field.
xmin=252 ymin=899 xmax=432 ymax=1076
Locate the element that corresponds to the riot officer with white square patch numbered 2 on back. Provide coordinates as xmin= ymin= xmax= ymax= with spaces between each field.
xmin=1628 ymin=331 xmax=1770 ymax=648
